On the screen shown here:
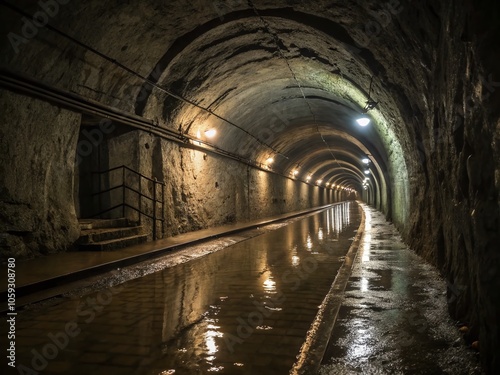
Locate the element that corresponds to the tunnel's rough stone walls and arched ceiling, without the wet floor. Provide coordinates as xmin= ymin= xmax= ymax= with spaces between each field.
xmin=0 ymin=0 xmax=500 ymax=374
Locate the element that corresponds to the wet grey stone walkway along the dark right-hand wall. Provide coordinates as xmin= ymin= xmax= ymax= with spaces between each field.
xmin=320 ymin=206 xmax=481 ymax=375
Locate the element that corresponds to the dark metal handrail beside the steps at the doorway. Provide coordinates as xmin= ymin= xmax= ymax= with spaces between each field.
xmin=91 ymin=165 xmax=165 ymax=240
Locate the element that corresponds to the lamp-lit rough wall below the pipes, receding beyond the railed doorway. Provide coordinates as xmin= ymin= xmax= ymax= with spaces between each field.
xmin=143 ymin=132 xmax=333 ymax=236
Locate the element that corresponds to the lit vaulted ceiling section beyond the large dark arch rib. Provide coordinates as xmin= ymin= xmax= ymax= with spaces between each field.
xmin=136 ymin=9 xmax=410 ymax=195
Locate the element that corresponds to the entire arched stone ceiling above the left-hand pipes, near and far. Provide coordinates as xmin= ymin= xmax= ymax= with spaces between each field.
xmin=3 ymin=0 xmax=420 ymax=200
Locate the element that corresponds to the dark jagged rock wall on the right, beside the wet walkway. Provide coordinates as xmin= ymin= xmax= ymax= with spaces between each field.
xmin=407 ymin=2 xmax=500 ymax=373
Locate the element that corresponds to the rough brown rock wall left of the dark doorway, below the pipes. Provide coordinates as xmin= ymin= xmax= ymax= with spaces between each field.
xmin=0 ymin=90 xmax=80 ymax=257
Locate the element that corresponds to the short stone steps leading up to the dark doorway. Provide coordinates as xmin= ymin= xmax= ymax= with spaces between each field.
xmin=76 ymin=218 xmax=148 ymax=251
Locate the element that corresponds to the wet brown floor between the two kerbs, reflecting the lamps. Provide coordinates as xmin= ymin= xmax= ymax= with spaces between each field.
xmin=5 ymin=202 xmax=360 ymax=375
